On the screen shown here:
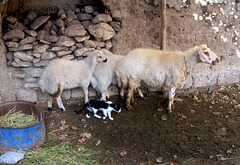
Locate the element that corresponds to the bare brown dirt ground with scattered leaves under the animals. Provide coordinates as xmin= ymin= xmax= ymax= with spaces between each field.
xmin=45 ymin=84 xmax=240 ymax=165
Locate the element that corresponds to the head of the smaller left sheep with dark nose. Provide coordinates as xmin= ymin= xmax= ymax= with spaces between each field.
xmin=89 ymin=50 xmax=107 ymax=69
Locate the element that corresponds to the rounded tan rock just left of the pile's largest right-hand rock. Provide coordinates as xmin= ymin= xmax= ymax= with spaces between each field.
xmin=65 ymin=25 xmax=87 ymax=37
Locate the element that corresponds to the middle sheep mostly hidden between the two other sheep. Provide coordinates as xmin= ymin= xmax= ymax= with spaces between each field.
xmin=91 ymin=49 xmax=143 ymax=100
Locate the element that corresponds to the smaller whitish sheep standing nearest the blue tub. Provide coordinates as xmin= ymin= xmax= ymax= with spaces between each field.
xmin=38 ymin=50 xmax=107 ymax=111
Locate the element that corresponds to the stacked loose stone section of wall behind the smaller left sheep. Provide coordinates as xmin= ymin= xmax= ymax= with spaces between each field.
xmin=2 ymin=6 xmax=121 ymax=102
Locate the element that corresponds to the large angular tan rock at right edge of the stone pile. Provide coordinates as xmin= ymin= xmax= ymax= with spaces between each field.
xmin=88 ymin=23 xmax=116 ymax=41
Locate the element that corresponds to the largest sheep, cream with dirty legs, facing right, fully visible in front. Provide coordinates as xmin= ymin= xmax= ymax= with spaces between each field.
xmin=116 ymin=45 xmax=220 ymax=113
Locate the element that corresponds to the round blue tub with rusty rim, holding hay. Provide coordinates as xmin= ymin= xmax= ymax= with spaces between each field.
xmin=0 ymin=101 xmax=46 ymax=152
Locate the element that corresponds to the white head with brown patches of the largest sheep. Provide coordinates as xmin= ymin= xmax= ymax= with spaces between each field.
xmin=198 ymin=45 xmax=220 ymax=65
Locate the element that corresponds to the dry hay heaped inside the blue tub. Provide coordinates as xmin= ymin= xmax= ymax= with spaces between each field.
xmin=0 ymin=107 xmax=39 ymax=128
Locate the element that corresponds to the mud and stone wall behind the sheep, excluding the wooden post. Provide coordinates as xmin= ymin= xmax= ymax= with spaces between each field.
xmin=0 ymin=0 xmax=240 ymax=102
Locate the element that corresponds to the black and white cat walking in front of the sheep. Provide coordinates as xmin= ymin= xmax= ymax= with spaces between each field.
xmin=75 ymin=99 xmax=121 ymax=120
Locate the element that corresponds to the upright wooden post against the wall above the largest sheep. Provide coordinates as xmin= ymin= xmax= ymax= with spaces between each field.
xmin=160 ymin=0 xmax=167 ymax=50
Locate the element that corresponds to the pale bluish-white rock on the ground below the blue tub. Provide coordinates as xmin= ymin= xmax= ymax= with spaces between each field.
xmin=0 ymin=152 xmax=24 ymax=164
